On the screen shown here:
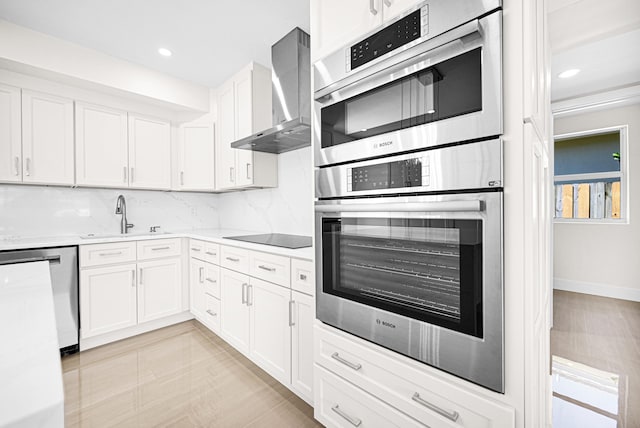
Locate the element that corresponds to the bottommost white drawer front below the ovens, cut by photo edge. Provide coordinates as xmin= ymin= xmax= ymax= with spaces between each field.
xmin=314 ymin=366 xmax=424 ymax=428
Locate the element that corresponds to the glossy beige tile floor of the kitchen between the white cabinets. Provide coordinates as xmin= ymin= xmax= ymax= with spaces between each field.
xmin=62 ymin=321 xmax=321 ymax=428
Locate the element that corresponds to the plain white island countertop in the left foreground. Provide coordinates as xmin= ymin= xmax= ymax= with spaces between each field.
xmin=0 ymin=262 xmax=64 ymax=428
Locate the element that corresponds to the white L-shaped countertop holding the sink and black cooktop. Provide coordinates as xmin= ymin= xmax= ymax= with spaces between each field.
xmin=0 ymin=229 xmax=314 ymax=260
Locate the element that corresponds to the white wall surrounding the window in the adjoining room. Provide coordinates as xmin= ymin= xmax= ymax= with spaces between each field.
xmin=554 ymin=104 xmax=640 ymax=301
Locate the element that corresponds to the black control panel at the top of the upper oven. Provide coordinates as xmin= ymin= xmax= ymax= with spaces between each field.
xmin=345 ymin=4 xmax=429 ymax=72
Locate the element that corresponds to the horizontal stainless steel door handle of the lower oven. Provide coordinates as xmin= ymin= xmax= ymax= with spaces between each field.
xmin=315 ymin=201 xmax=483 ymax=213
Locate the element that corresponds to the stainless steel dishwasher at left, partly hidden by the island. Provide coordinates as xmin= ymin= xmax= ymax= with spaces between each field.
xmin=0 ymin=247 xmax=79 ymax=354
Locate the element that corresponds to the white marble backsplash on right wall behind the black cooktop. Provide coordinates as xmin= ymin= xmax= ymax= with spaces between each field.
xmin=218 ymin=147 xmax=313 ymax=236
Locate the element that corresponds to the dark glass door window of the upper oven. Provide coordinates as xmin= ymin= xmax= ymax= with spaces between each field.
xmin=320 ymin=47 xmax=483 ymax=148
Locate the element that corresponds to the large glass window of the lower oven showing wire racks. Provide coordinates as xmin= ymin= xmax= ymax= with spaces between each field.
xmin=321 ymin=215 xmax=483 ymax=338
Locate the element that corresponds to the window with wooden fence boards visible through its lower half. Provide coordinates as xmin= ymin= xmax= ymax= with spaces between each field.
xmin=554 ymin=126 xmax=627 ymax=222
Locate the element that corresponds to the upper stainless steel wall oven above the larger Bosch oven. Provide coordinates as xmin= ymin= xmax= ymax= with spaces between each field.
xmin=313 ymin=0 xmax=502 ymax=167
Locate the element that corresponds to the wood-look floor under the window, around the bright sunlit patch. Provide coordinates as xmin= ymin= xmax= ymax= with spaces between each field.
xmin=551 ymin=290 xmax=640 ymax=428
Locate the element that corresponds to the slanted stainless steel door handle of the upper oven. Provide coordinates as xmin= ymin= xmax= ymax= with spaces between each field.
xmin=315 ymin=19 xmax=480 ymax=102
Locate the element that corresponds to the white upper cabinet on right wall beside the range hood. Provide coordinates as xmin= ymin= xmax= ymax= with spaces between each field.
xmin=215 ymin=63 xmax=278 ymax=190
